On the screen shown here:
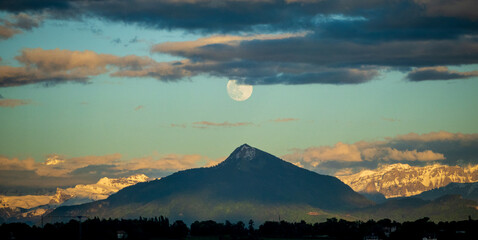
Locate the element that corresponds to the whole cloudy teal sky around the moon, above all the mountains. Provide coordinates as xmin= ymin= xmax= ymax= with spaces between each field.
xmin=0 ymin=0 xmax=478 ymax=189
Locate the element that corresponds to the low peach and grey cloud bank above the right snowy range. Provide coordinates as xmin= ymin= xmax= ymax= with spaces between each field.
xmin=283 ymin=131 xmax=478 ymax=174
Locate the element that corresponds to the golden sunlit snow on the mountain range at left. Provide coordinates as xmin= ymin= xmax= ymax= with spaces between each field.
xmin=0 ymin=174 xmax=149 ymax=215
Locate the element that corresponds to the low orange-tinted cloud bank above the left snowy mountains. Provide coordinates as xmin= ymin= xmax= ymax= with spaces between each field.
xmin=0 ymin=153 xmax=215 ymax=192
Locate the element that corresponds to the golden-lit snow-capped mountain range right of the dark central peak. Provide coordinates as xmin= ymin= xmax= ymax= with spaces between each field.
xmin=336 ymin=163 xmax=478 ymax=198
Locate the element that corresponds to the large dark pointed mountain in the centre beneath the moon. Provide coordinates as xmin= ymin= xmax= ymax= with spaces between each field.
xmin=49 ymin=144 xmax=373 ymax=221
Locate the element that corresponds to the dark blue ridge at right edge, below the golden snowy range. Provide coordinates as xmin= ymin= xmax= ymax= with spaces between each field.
xmin=416 ymin=182 xmax=478 ymax=201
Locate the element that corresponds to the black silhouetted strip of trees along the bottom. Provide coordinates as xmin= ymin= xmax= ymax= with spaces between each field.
xmin=0 ymin=217 xmax=478 ymax=240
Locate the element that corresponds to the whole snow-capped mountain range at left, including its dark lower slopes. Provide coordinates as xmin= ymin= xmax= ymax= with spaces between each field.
xmin=0 ymin=174 xmax=148 ymax=223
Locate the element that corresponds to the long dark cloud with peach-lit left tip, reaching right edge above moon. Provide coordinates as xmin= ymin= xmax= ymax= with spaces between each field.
xmin=153 ymin=34 xmax=478 ymax=67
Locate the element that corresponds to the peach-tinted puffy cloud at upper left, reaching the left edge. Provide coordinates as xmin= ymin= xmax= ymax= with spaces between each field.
xmin=0 ymin=48 xmax=191 ymax=87
